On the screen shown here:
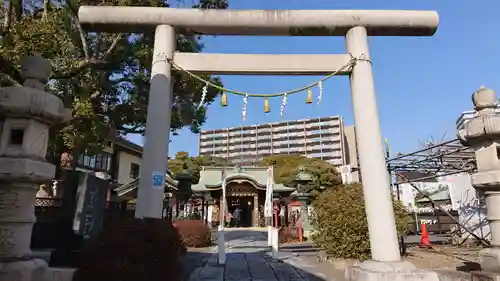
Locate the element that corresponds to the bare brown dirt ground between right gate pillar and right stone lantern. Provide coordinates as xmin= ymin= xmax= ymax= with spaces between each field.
xmin=405 ymin=246 xmax=482 ymax=271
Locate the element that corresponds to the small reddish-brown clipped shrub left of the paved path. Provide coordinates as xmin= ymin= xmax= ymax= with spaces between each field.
xmin=174 ymin=219 xmax=212 ymax=248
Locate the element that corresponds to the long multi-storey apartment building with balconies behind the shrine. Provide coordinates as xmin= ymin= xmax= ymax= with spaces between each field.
xmin=199 ymin=116 xmax=357 ymax=167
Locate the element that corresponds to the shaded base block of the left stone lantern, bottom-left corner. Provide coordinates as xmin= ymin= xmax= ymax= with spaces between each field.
xmin=0 ymin=259 xmax=48 ymax=281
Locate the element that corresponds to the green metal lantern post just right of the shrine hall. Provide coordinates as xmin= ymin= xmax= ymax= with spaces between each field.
xmin=293 ymin=167 xmax=313 ymax=237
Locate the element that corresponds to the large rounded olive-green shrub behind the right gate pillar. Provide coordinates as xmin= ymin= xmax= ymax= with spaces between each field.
xmin=312 ymin=184 xmax=408 ymax=260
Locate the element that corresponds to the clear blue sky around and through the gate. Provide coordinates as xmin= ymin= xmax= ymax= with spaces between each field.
xmin=129 ymin=0 xmax=500 ymax=158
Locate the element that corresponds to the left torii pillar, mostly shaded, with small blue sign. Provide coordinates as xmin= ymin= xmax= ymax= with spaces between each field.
xmin=135 ymin=25 xmax=176 ymax=218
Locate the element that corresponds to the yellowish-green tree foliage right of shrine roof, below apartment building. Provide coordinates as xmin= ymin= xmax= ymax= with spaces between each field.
xmin=260 ymin=155 xmax=341 ymax=195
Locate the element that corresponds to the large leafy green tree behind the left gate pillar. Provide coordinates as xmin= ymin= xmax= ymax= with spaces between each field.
xmin=0 ymin=0 xmax=227 ymax=163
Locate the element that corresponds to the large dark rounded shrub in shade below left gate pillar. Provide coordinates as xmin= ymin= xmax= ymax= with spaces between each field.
xmin=73 ymin=218 xmax=185 ymax=281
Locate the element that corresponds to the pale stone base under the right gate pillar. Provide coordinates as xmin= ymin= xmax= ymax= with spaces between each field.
xmin=345 ymin=260 xmax=439 ymax=281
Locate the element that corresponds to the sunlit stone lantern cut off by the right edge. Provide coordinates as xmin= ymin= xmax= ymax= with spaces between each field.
xmin=458 ymin=86 xmax=500 ymax=273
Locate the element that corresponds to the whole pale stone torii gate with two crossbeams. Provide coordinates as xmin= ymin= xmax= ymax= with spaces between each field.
xmin=79 ymin=6 xmax=439 ymax=262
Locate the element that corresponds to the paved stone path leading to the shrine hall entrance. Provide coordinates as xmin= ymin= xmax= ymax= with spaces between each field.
xmin=189 ymin=229 xmax=337 ymax=281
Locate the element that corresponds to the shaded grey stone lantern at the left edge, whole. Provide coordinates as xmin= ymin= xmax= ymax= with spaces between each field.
xmin=0 ymin=56 xmax=71 ymax=281
